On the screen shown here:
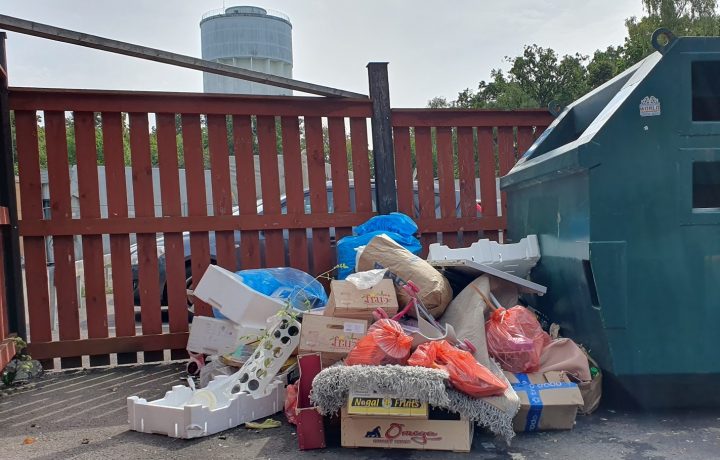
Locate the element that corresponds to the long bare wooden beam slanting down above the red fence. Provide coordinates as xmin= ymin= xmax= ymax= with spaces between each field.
xmin=0 ymin=14 xmax=367 ymax=97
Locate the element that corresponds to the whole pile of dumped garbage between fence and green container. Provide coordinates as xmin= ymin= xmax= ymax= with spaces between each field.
xmin=128 ymin=213 xmax=601 ymax=451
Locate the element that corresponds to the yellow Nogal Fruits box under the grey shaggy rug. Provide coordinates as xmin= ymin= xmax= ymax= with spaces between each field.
xmin=347 ymin=387 xmax=428 ymax=420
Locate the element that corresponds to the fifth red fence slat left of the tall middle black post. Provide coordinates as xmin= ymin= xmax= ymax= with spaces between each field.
xmin=257 ymin=116 xmax=285 ymax=267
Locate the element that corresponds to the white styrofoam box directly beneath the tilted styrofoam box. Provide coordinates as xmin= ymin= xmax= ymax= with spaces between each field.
xmin=186 ymin=316 xmax=242 ymax=355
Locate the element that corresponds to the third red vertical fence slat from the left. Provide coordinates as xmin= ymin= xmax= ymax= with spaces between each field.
xmin=75 ymin=112 xmax=110 ymax=366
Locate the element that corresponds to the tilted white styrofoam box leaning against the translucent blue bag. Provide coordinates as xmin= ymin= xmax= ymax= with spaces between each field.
xmin=193 ymin=265 xmax=285 ymax=330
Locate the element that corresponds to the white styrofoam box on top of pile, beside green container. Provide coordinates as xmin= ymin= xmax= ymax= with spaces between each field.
xmin=428 ymin=235 xmax=540 ymax=278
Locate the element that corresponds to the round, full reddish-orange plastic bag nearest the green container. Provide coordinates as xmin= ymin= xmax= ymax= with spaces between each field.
xmin=485 ymin=305 xmax=550 ymax=372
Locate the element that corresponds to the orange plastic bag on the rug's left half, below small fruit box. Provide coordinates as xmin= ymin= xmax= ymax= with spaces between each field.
xmin=345 ymin=319 xmax=412 ymax=366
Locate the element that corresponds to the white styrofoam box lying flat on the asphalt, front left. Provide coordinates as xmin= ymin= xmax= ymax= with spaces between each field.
xmin=127 ymin=376 xmax=285 ymax=439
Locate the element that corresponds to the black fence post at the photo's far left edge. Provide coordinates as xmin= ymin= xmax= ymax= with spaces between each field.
xmin=0 ymin=32 xmax=27 ymax=339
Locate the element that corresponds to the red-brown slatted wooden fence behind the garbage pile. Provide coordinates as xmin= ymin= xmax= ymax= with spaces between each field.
xmin=8 ymin=88 xmax=551 ymax=367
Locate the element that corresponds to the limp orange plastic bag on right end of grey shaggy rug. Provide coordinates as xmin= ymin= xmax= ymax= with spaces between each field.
xmin=408 ymin=340 xmax=507 ymax=398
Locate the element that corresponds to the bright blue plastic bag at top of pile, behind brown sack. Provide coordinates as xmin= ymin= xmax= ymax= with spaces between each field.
xmin=337 ymin=212 xmax=422 ymax=280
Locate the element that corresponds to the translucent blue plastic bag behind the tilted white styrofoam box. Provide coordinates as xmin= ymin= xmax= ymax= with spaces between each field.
xmin=213 ymin=267 xmax=328 ymax=319
